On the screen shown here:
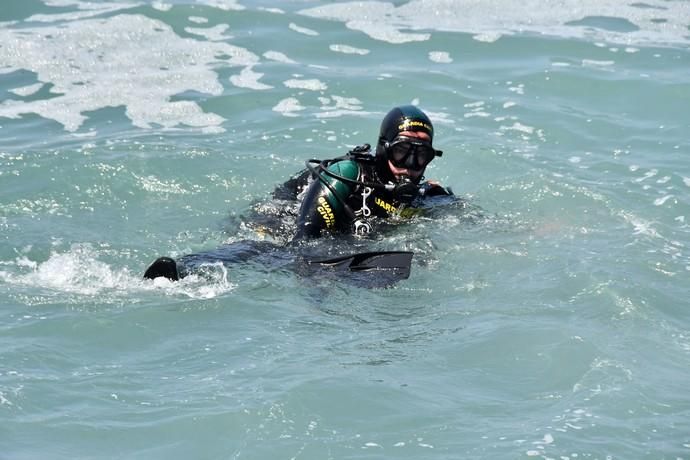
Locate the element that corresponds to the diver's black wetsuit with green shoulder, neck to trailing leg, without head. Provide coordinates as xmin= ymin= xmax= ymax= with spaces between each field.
xmin=145 ymin=150 xmax=456 ymax=286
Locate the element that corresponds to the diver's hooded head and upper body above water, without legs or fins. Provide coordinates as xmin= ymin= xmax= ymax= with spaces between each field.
xmin=284 ymin=105 xmax=453 ymax=240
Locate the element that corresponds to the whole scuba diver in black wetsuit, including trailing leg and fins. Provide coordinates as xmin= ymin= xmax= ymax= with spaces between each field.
xmin=144 ymin=105 xmax=456 ymax=281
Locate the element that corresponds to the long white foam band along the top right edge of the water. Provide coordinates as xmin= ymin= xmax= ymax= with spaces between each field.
xmin=300 ymin=0 xmax=690 ymax=45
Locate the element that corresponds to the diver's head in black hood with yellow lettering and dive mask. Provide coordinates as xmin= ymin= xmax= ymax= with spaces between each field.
xmin=376 ymin=105 xmax=442 ymax=184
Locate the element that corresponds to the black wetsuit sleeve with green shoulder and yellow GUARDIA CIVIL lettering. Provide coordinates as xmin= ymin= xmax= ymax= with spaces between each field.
xmin=295 ymin=161 xmax=359 ymax=239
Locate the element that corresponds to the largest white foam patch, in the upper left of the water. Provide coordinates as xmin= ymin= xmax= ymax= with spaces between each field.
xmin=0 ymin=12 xmax=270 ymax=132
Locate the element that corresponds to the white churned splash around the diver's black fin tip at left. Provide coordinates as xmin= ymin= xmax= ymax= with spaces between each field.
xmin=0 ymin=244 xmax=235 ymax=303
